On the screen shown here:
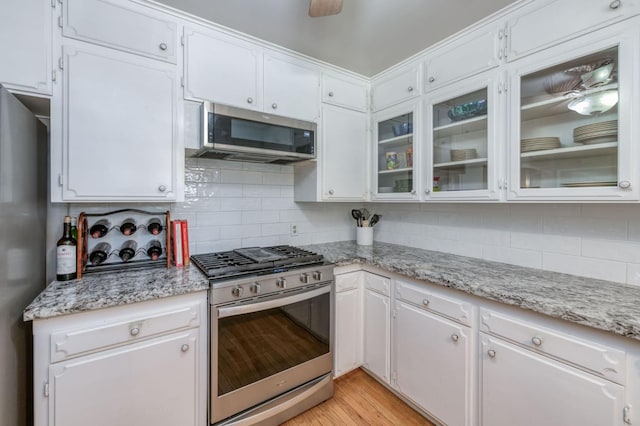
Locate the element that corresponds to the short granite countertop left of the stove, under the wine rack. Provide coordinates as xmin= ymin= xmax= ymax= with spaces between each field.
xmin=23 ymin=266 xmax=209 ymax=321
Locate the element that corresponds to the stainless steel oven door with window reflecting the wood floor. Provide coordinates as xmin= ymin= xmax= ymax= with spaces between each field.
xmin=210 ymin=282 xmax=333 ymax=423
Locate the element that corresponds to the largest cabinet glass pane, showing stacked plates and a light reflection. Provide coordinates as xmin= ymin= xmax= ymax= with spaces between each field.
xmin=520 ymin=47 xmax=618 ymax=188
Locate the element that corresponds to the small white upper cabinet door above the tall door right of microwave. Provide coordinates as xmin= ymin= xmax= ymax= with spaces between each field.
xmin=322 ymin=73 xmax=369 ymax=112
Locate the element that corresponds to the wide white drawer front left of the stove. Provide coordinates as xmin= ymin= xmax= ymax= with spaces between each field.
xmin=51 ymin=304 xmax=201 ymax=362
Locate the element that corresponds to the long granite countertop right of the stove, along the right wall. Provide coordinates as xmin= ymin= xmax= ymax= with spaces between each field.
xmin=304 ymin=241 xmax=640 ymax=340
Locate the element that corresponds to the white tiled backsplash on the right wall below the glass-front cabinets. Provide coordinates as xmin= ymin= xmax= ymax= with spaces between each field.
xmin=368 ymin=203 xmax=640 ymax=285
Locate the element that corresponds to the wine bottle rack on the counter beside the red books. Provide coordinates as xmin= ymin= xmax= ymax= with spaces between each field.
xmin=77 ymin=209 xmax=171 ymax=278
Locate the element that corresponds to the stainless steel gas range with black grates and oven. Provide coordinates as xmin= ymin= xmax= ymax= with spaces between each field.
xmin=191 ymin=246 xmax=334 ymax=425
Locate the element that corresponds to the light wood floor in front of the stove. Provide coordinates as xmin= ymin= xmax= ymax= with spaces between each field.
xmin=282 ymin=369 xmax=434 ymax=426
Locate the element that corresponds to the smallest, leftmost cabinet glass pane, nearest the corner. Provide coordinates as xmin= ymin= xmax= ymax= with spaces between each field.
xmin=378 ymin=112 xmax=413 ymax=193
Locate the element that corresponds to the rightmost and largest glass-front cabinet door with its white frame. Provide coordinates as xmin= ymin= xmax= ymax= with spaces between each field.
xmin=508 ymin=25 xmax=639 ymax=200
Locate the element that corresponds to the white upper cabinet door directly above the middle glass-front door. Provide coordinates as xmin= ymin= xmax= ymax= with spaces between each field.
xmin=424 ymin=24 xmax=505 ymax=92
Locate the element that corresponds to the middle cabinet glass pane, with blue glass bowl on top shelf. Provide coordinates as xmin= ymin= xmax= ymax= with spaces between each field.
xmin=433 ymin=88 xmax=488 ymax=192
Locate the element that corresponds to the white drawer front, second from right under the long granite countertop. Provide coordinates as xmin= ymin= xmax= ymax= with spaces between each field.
xmin=394 ymin=281 xmax=473 ymax=325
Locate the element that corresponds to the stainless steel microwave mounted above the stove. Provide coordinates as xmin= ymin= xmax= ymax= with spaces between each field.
xmin=196 ymin=102 xmax=317 ymax=164
